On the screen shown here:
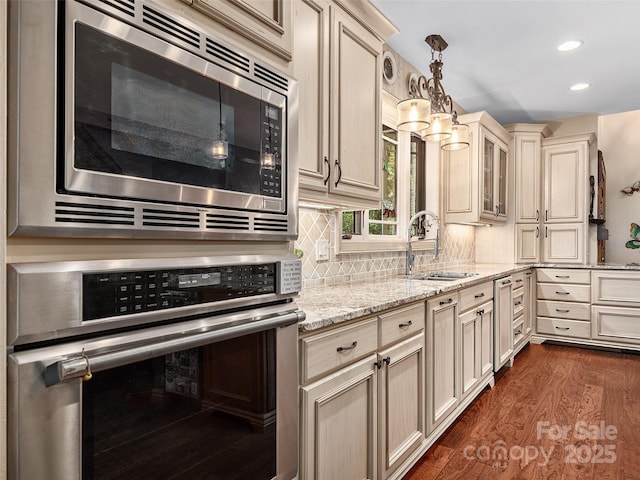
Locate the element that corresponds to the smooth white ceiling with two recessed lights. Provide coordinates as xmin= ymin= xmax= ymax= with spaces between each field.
xmin=371 ymin=0 xmax=640 ymax=125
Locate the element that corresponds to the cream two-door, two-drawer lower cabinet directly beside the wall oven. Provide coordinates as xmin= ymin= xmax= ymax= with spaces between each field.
xmin=300 ymin=302 xmax=426 ymax=480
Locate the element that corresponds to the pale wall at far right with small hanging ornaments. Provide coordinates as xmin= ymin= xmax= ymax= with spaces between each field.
xmin=598 ymin=110 xmax=640 ymax=264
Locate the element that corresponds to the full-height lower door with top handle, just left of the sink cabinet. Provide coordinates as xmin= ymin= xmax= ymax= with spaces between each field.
xmin=426 ymin=293 xmax=460 ymax=431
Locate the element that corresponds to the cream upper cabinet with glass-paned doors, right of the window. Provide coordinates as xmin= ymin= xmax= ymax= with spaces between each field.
xmin=442 ymin=112 xmax=511 ymax=224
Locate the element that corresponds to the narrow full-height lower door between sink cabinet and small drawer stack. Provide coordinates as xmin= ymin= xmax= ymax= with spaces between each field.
xmin=493 ymin=277 xmax=513 ymax=371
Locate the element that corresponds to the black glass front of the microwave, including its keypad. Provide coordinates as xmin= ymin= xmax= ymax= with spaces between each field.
xmin=71 ymin=22 xmax=283 ymax=204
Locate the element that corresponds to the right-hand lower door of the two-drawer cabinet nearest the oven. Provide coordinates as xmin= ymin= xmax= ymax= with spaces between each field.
xmin=380 ymin=331 xmax=426 ymax=479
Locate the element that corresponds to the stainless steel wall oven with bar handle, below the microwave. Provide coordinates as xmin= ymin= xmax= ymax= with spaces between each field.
xmin=8 ymin=255 xmax=304 ymax=480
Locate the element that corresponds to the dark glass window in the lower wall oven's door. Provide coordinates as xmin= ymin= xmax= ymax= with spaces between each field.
xmin=82 ymin=330 xmax=276 ymax=480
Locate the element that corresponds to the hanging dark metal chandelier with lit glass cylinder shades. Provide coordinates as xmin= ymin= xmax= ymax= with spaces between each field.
xmin=397 ymin=35 xmax=469 ymax=150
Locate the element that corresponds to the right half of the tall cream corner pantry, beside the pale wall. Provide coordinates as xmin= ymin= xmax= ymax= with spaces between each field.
xmin=541 ymin=134 xmax=596 ymax=263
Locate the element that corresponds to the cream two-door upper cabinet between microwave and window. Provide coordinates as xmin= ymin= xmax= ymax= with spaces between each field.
xmin=293 ymin=0 xmax=395 ymax=208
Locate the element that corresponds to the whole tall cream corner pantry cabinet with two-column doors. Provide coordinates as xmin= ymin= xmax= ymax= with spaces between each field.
xmin=507 ymin=124 xmax=596 ymax=264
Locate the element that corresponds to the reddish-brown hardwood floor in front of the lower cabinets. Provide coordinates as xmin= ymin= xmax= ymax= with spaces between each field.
xmin=404 ymin=344 xmax=640 ymax=480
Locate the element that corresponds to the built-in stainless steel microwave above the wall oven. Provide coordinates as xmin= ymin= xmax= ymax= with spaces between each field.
xmin=8 ymin=0 xmax=298 ymax=240
